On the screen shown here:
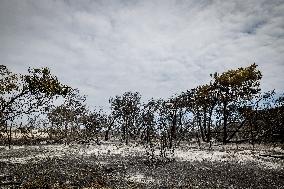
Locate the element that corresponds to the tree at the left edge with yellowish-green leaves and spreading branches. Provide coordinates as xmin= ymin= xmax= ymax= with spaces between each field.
xmin=0 ymin=65 xmax=69 ymax=147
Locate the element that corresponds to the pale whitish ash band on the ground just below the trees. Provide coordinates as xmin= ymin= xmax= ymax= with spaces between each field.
xmin=0 ymin=142 xmax=284 ymax=169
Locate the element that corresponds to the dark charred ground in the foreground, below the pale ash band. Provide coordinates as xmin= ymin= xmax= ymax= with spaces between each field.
xmin=0 ymin=145 xmax=284 ymax=189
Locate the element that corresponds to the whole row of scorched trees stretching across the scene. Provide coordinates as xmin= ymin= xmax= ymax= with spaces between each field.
xmin=0 ymin=64 xmax=284 ymax=149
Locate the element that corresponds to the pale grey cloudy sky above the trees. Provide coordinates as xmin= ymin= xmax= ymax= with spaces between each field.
xmin=0 ymin=0 xmax=284 ymax=108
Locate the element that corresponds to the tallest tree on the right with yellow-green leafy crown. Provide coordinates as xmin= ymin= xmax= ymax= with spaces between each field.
xmin=212 ymin=63 xmax=262 ymax=144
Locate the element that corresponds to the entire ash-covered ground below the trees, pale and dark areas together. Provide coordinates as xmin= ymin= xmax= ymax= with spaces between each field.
xmin=0 ymin=141 xmax=284 ymax=189
